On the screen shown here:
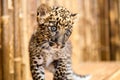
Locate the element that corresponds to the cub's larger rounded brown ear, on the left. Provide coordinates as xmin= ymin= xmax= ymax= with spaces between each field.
xmin=37 ymin=4 xmax=51 ymax=16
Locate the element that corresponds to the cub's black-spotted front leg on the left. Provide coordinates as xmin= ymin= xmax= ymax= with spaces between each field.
xmin=30 ymin=54 xmax=45 ymax=80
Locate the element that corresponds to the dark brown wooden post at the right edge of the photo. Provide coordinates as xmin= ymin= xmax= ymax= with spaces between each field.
xmin=110 ymin=0 xmax=120 ymax=60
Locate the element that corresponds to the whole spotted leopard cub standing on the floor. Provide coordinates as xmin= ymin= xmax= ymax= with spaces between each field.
xmin=29 ymin=4 xmax=90 ymax=80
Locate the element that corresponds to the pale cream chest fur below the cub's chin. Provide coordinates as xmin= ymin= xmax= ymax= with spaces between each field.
xmin=40 ymin=43 xmax=70 ymax=67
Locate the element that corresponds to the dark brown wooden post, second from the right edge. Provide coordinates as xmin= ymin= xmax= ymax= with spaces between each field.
xmin=98 ymin=0 xmax=110 ymax=60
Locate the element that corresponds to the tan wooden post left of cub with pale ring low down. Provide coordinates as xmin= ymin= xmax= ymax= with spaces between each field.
xmin=14 ymin=0 xmax=23 ymax=80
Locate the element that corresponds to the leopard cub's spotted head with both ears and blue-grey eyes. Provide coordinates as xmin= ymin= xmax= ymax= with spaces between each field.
xmin=37 ymin=4 xmax=77 ymax=48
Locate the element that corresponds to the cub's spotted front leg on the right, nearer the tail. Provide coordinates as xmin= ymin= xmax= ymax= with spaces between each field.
xmin=53 ymin=58 xmax=73 ymax=80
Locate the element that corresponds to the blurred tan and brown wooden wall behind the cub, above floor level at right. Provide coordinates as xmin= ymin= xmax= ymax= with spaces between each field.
xmin=0 ymin=0 xmax=120 ymax=80
